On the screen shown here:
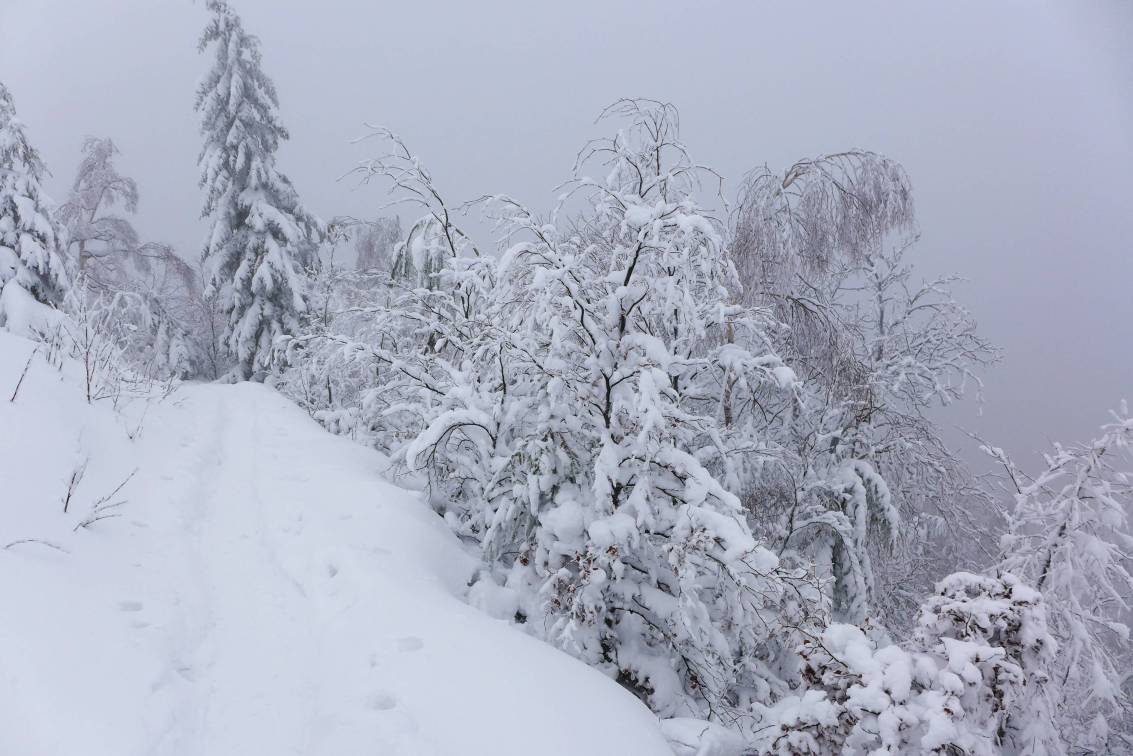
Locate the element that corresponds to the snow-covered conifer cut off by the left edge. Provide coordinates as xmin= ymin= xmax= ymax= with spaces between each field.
xmin=0 ymin=84 xmax=68 ymax=325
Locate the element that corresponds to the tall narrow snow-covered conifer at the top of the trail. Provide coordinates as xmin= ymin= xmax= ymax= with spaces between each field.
xmin=196 ymin=0 xmax=322 ymax=380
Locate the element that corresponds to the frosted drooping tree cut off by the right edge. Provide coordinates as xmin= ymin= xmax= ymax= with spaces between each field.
xmin=985 ymin=405 xmax=1133 ymax=753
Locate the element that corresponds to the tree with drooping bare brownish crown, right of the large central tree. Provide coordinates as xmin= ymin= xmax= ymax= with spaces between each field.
xmin=731 ymin=151 xmax=995 ymax=623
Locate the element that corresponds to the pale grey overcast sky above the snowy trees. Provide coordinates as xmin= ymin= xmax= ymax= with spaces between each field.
xmin=0 ymin=0 xmax=1133 ymax=466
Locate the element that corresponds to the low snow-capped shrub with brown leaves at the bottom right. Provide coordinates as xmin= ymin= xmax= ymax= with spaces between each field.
xmin=756 ymin=572 xmax=1064 ymax=756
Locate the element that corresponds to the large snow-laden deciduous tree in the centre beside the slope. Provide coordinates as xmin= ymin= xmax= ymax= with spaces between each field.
xmin=387 ymin=101 xmax=813 ymax=721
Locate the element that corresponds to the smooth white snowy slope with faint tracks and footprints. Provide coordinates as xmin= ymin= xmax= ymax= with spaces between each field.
xmin=0 ymin=331 xmax=672 ymax=756
